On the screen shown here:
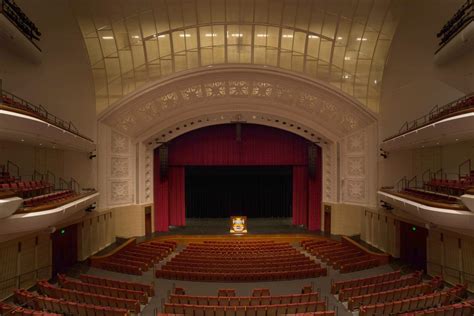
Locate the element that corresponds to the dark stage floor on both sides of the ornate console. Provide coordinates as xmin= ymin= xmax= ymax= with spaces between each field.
xmin=156 ymin=217 xmax=309 ymax=235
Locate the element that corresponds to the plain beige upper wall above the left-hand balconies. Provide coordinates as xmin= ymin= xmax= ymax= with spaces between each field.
xmin=0 ymin=0 xmax=96 ymax=139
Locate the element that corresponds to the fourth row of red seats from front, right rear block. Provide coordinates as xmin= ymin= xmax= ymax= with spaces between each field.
xmin=359 ymin=291 xmax=451 ymax=316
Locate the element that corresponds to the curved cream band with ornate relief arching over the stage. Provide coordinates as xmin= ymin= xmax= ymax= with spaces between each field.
xmin=99 ymin=65 xmax=376 ymax=142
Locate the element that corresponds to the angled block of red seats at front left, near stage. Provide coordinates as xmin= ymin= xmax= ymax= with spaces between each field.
xmin=91 ymin=241 xmax=176 ymax=275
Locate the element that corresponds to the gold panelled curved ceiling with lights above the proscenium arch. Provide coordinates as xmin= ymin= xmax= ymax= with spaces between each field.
xmin=71 ymin=0 xmax=400 ymax=113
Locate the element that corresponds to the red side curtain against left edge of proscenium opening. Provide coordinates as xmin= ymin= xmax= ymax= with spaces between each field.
xmin=153 ymin=150 xmax=169 ymax=232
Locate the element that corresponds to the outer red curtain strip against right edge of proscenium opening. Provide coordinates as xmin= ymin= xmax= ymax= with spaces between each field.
xmin=308 ymin=146 xmax=323 ymax=231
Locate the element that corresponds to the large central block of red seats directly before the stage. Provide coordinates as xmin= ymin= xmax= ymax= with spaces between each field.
xmin=156 ymin=240 xmax=327 ymax=281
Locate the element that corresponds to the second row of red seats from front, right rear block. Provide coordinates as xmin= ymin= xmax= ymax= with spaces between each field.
xmin=338 ymin=272 xmax=421 ymax=302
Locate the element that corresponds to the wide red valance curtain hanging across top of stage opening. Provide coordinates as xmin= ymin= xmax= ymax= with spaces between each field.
xmin=168 ymin=124 xmax=308 ymax=166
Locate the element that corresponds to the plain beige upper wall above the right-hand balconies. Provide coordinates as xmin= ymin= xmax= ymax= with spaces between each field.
xmin=380 ymin=0 xmax=474 ymax=139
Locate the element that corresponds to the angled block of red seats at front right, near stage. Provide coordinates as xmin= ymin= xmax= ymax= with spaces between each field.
xmin=301 ymin=239 xmax=380 ymax=273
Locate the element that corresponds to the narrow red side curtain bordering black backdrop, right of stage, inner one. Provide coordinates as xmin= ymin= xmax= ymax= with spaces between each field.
xmin=293 ymin=166 xmax=308 ymax=226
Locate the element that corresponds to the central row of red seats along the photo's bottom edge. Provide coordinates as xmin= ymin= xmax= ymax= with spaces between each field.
xmin=164 ymin=301 xmax=326 ymax=316
